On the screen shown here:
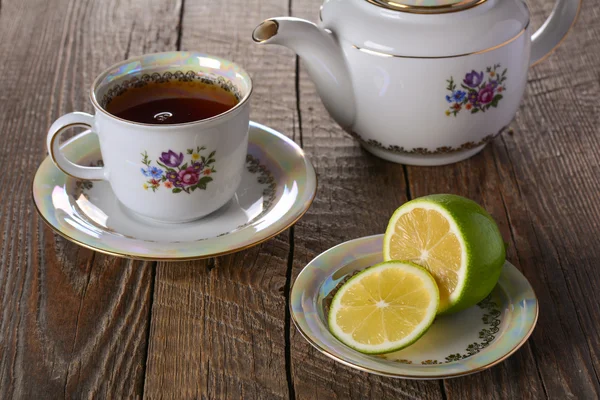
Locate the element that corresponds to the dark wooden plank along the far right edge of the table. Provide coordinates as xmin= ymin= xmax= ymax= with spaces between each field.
xmin=492 ymin=3 xmax=600 ymax=399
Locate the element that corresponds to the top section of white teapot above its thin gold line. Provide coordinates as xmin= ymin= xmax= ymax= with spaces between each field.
xmin=319 ymin=0 xmax=529 ymax=58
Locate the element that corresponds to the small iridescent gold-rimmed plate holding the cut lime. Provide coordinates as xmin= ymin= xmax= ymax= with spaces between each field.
xmin=290 ymin=235 xmax=538 ymax=379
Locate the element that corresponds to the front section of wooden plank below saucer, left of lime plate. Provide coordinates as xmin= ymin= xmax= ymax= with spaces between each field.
xmin=145 ymin=245 xmax=289 ymax=399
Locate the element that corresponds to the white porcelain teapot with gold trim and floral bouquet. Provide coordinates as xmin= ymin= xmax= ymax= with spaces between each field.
xmin=252 ymin=0 xmax=580 ymax=165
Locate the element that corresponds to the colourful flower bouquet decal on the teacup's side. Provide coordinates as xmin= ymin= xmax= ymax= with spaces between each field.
xmin=141 ymin=146 xmax=217 ymax=193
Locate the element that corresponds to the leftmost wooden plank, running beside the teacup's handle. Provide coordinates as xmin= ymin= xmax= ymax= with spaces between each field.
xmin=0 ymin=0 xmax=178 ymax=399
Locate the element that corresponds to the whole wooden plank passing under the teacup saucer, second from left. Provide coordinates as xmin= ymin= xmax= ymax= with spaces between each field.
xmin=145 ymin=0 xmax=296 ymax=399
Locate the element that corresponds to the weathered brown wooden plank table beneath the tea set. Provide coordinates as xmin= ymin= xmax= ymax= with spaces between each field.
xmin=0 ymin=0 xmax=600 ymax=399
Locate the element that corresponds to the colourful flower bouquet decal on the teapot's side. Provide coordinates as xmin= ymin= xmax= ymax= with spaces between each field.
xmin=446 ymin=64 xmax=506 ymax=117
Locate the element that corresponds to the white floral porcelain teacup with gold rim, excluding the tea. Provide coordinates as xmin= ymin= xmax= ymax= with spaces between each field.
xmin=47 ymin=52 xmax=252 ymax=222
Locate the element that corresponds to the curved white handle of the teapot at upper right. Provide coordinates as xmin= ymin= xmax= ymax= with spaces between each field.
xmin=529 ymin=0 xmax=582 ymax=66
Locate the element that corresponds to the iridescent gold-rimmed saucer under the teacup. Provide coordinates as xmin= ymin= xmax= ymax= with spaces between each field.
xmin=33 ymin=122 xmax=317 ymax=260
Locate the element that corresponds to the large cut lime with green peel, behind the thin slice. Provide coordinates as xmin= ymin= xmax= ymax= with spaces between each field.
xmin=383 ymin=194 xmax=506 ymax=314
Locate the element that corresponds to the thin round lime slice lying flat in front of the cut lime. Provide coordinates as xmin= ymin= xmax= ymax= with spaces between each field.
xmin=329 ymin=261 xmax=439 ymax=354
